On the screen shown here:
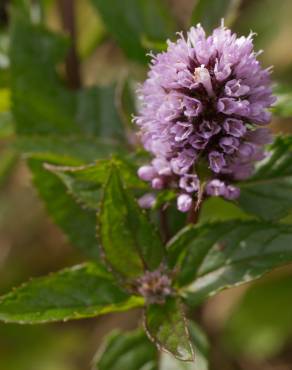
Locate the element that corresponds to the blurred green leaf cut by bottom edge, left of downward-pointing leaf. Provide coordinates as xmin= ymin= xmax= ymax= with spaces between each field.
xmin=96 ymin=330 xmax=158 ymax=370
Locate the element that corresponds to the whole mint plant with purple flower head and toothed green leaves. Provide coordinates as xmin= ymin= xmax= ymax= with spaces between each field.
xmin=0 ymin=0 xmax=292 ymax=370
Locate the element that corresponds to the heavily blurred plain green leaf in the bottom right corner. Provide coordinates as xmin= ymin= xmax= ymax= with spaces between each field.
xmin=223 ymin=272 xmax=292 ymax=359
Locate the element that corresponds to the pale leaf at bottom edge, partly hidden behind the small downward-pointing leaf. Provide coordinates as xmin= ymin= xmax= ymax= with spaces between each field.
xmin=159 ymin=322 xmax=209 ymax=370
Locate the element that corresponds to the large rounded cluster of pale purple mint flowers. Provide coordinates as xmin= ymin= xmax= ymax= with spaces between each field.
xmin=135 ymin=25 xmax=275 ymax=212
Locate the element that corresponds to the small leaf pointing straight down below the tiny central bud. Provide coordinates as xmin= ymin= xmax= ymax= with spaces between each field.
xmin=144 ymin=297 xmax=194 ymax=361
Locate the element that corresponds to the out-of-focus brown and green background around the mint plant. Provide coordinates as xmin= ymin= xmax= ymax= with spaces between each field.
xmin=0 ymin=0 xmax=292 ymax=370
